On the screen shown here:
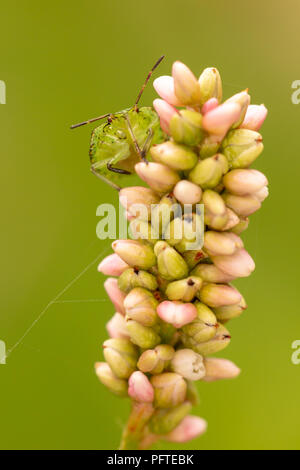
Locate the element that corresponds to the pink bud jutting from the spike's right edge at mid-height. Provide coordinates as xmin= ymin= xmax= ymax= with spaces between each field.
xmin=211 ymin=248 xmax=255 ymax=277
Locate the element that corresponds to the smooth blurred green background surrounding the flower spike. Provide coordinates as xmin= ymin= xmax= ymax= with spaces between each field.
xmin=0 ymin=0 xmax=300 ymax=449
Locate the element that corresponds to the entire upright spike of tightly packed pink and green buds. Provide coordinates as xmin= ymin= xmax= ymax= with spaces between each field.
xmin=96 ymin=62 xmax=268 ymax=448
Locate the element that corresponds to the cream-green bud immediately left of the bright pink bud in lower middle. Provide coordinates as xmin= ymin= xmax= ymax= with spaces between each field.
xmin=124 ymin=286 xmax=158 ymax=326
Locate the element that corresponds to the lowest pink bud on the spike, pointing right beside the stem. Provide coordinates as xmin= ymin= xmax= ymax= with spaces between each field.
xmin=164 ymin=415 xmax=207 ymax=443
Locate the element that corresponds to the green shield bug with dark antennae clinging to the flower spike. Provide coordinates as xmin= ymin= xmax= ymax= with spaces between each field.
xmin=71 ymin=56 xmax=164 ymax=190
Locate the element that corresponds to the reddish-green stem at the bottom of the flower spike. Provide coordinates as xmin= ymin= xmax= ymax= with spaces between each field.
xmin=119 ymin=402 xmax=154 ymax=450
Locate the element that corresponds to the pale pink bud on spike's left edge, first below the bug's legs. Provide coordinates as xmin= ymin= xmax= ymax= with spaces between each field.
xmin=119 ymin=186 xmax=159 ymax=219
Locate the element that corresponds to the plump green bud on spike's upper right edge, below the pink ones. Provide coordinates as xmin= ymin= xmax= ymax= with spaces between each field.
xmin=222 ymin=129 xmax=264 ymax=168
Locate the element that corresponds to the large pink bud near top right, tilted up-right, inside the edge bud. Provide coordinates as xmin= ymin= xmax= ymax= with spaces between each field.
xmin=202 ymin=103 xmax=241 ymax=135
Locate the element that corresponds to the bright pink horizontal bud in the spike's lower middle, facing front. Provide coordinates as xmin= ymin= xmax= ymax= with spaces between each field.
xmin=157 ymin=300 xmax=197 ymax=328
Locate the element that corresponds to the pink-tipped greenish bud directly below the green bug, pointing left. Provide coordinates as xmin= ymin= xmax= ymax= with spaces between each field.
xmin=134 ymin=162 xmax=180 ymax=194
